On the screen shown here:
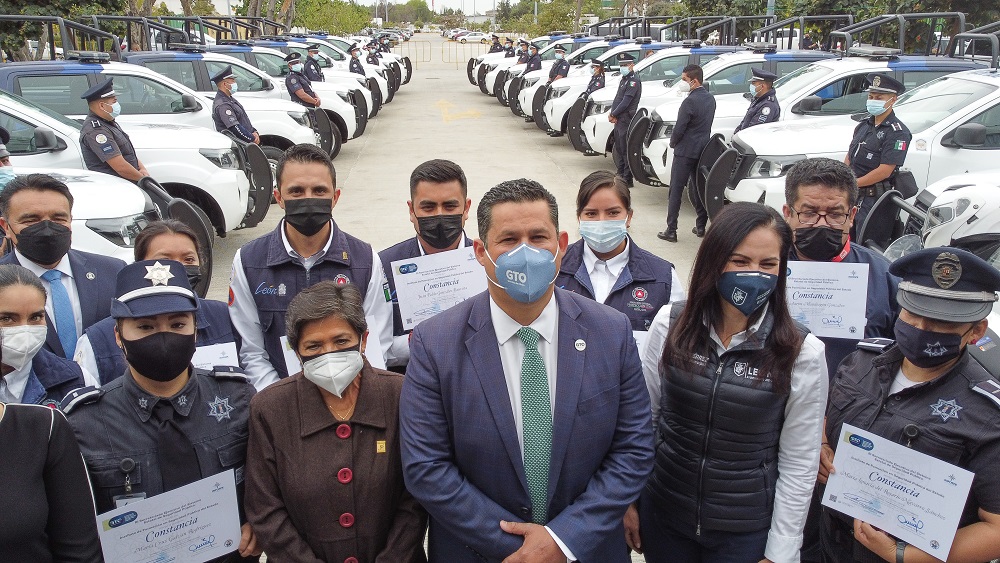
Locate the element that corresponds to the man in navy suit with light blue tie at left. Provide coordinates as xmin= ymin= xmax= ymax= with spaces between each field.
xmin=0 ymin=174 xmax=125 ymax=359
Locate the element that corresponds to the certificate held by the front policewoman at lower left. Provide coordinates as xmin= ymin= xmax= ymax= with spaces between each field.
xmin=97 ymin=469 xmax=240 ymax=563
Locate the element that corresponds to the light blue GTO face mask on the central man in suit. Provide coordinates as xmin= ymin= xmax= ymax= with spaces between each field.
xmin=486 ymin=243 xmax=556 ymax=303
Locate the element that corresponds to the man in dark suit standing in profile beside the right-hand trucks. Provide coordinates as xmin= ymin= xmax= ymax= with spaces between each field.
xmin=656 ymin=65 xmax=715 ymax=242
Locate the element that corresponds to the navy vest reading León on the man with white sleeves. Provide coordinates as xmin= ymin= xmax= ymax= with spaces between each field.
xmin=240 ymin=221 xmax=373 ymax=378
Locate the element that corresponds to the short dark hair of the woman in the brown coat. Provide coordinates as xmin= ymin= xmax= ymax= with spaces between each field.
xmin=285 ymin=280 xmax=368 ymax=352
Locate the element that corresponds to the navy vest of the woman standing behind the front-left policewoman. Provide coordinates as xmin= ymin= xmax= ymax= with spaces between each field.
xmin=84 ymin=299 xmax=239 ymax=385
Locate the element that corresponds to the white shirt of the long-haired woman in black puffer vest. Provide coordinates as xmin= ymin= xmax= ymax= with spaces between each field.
xmin=640 ymin=305 xmax=829 ymax=561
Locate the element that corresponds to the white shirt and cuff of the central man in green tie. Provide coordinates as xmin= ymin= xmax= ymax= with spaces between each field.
xmin=490 ymin=295 xmax=576 ymax=561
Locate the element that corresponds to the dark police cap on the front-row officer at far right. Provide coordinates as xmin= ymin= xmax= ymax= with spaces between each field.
xmin=889 ymin=247 xmax=1000 ymax=323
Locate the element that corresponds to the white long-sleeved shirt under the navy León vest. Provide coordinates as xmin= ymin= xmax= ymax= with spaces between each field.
xmin=229 ymin=219 xmax=392 ymax=391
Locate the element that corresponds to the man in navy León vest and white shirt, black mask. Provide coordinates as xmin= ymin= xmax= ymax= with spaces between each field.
xmin=229 ymin=144 xmax=392 ymax=390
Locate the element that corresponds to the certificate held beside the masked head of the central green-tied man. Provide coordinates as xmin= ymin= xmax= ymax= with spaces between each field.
xmin=390 ymin=246 xmax=487 ymax=330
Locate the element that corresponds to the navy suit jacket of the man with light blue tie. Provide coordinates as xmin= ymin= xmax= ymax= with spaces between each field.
xmin=0 ymin=250 xmax=125 ymax=357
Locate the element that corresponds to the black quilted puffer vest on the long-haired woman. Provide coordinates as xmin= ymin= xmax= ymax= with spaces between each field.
xmin=646 ymin=303 xmax=805 ymax=533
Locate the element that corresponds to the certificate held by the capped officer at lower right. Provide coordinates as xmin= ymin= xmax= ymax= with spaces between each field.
xmin=823 ymin=424 xmax=974 ymax=561
